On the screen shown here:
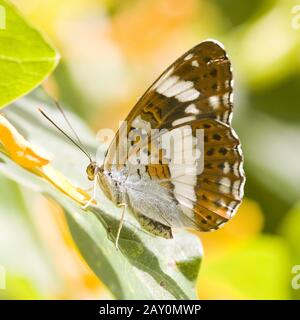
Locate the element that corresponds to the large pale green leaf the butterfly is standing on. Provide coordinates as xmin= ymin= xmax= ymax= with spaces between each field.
xmin=0 ymin=89 xmax=202 ymax=299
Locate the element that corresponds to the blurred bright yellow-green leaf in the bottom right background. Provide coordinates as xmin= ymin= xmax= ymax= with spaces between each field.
xmin=199 ymin=236 xmax=290 ymax=299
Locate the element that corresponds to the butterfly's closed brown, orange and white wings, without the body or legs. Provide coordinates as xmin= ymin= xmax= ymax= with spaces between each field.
xmin=104 ymin=41 xmax=245 ymax=231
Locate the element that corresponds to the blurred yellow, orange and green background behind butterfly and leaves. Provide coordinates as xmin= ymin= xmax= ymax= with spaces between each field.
xmin=0 ymin=0 xmax=300 ymax=299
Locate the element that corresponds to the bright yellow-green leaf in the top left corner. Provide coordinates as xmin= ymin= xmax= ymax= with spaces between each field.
xmin=0 ymin=0 xmax=59 ymax=108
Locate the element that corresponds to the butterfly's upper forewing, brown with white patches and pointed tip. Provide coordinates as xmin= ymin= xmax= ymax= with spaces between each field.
xmin=129 ymin=41 xmax=232 ymax=128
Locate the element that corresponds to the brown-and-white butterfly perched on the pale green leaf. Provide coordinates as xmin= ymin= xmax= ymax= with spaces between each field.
xmin=41 ymin=40 xmax=245 ymax=248
